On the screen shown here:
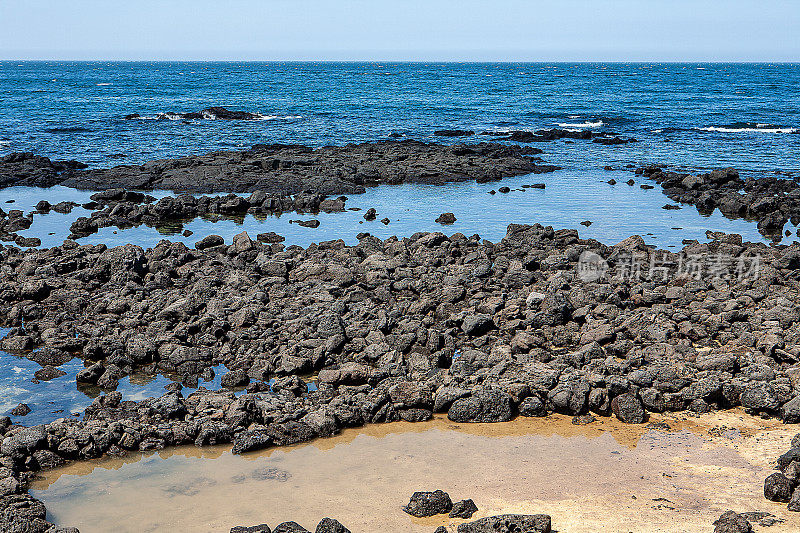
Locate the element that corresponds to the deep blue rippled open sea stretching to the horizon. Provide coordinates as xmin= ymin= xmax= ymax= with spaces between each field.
xmin=0 ymin=61 xmax=800 ymax=170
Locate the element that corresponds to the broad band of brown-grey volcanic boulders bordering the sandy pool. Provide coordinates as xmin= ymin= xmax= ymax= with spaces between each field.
xmin=0 ymin=220 xmax=800 ymax=531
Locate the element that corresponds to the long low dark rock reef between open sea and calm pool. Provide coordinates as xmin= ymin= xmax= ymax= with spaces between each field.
xmin=0 ymin=140 xmax=558 ymax=195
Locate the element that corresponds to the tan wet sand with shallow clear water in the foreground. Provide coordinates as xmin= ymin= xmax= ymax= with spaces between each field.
xmin=32 ymin=411 xmax=800 ymax=533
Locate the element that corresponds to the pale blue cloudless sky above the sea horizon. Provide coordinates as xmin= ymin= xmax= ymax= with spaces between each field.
xmin=0 ymin=0 xmax=800 ymax=61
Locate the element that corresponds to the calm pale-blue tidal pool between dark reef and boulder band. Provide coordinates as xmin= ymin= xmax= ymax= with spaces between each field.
xmin=0 ymin=170 xmax=797 ymax=248
